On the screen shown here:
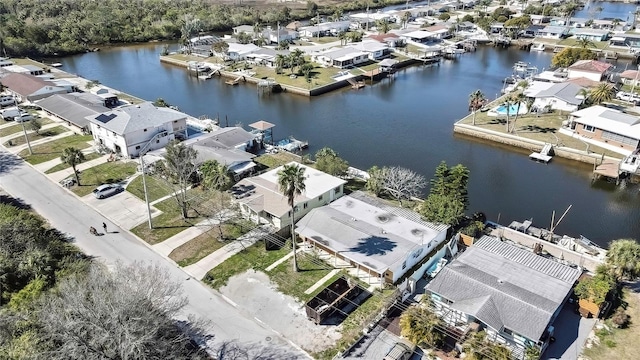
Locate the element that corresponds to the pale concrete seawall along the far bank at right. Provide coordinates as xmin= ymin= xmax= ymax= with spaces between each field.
xmin=453 ymin=123 xmax=619 ymax=164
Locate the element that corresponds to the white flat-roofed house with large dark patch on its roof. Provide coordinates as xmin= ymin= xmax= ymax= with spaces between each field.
xmin=296 ymin=192 xmax=449 ymax=284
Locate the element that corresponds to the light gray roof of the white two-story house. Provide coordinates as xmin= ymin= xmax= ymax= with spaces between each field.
xmin=87 ymin=102 xmax=187 ymax=135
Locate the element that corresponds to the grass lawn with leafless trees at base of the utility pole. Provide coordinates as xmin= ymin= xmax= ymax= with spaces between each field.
xmin=131 ymin=189 xmax=225 ymax=245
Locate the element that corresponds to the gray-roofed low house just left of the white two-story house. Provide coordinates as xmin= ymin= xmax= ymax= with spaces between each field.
xmin=36 ymin=92 xmax=110 ymax=133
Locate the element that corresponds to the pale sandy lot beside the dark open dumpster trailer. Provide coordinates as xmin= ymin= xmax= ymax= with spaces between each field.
xmin=220 ymin=270 xmax=340 ymax=352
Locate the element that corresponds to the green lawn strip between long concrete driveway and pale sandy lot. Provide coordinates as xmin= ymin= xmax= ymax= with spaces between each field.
xmin=205 ymin=241 xmax=291 ymax=289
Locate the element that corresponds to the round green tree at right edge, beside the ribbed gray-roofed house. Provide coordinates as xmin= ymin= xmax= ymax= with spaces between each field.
xmin=606 ymin=239 xmax=640 ymax=280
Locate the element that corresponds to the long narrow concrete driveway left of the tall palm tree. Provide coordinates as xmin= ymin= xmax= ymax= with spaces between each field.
xmin=184 ymin=226 xmax=269 ymax=280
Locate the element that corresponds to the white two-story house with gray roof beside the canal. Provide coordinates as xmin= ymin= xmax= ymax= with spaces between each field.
xmin=86 ymin=102 xmax=188 ymax=158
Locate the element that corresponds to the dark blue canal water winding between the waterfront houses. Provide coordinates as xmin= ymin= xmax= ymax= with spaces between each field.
xmin=60 ymin=44 xmax=640 ymax=245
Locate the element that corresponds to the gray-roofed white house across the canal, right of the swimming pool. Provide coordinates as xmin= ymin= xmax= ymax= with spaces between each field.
xmin=528 ymin=82 xmax=585 ymax=111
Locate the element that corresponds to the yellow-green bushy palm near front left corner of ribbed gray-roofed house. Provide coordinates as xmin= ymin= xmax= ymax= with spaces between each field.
xmin=400 ymin=306 xmax=443 ymax=347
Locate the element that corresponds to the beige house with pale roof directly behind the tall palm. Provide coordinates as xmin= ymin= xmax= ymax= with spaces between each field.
xmin=231 ymin=162 xmax=346 ymax=229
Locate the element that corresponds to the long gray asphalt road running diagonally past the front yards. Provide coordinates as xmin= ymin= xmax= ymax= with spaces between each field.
xmin=0 ymin=146 xmax=308 ymax=359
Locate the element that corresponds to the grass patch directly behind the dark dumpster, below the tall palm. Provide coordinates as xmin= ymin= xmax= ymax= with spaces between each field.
xmin=267 ymin=255 xmax=331 ymax=303
